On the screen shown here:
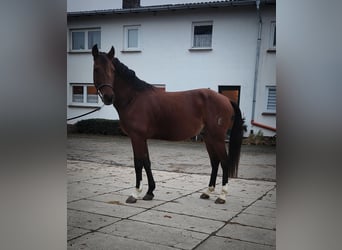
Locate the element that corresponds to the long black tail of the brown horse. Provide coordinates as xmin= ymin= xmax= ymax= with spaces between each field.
xmin=228 ymin=101 xmax=245 ymax=178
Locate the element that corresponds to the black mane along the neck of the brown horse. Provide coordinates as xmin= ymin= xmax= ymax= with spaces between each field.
xmin=113 ymin=57 xmax=155 ymax=91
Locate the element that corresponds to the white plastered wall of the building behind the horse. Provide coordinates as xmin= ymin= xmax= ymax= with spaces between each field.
xmin=68 ymin=4 xmax=275 ymax=133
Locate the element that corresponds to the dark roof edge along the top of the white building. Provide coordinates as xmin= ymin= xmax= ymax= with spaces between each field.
xmin=67 ymin=0 xmax=276 ymax=17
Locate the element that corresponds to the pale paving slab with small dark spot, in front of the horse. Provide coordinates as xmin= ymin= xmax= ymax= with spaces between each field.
xmin=130 ymin=210 xmax=224 ymax=234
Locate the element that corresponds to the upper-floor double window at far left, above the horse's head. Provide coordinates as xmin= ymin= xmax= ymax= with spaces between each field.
xmin=70 ymin=29 xmax=101 ymax=51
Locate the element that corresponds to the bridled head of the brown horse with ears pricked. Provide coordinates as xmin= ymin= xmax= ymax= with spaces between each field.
xmin=92 ymin=44 xmax=115 ymax=105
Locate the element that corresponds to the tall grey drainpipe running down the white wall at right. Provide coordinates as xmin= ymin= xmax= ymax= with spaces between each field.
xmin=251 ymin=0 xmax=262 ymax=133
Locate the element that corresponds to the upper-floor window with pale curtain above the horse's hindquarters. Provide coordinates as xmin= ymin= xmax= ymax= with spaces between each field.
xmin=191 ymin=22 xmax=213 ymax=49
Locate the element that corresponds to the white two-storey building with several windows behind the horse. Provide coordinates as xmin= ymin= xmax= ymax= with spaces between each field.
xmin=67 ymin=0 xmax=276 ymax=136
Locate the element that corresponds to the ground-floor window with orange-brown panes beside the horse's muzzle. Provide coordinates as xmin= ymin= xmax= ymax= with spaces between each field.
xmin=71 ymin=83 xmax=99 ymax=106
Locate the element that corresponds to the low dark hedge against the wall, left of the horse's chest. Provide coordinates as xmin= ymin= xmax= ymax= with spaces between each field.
xmin=75 ymin=119 xmax=125 ymax=135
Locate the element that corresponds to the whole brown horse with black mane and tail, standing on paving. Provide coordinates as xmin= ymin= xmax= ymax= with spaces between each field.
xmin=92 ymin=45 xmax=243 ymax=203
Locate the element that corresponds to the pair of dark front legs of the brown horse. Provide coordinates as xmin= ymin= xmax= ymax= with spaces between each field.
xmin=126 ymin=138 xmax=155 ymax=203
